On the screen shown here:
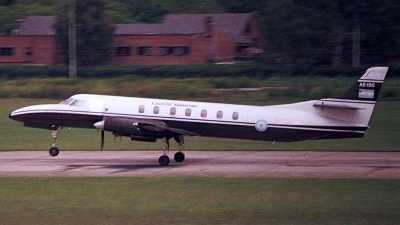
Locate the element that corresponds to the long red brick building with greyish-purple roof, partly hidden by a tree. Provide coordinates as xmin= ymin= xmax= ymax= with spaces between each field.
xmin=0 ymin=13 xmax=262 ymax=66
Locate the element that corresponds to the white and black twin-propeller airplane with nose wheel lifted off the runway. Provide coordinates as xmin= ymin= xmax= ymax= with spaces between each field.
xmin=9 ymin=67 xmax=388 ymax=166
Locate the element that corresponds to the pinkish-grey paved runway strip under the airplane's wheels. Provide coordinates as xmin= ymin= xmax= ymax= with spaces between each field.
xmin=0 ymin=151 xmax=400 ymax=179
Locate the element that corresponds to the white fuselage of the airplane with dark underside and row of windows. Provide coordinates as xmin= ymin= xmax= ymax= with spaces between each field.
xmin=10 ymin=94 xmax=373 ymax=142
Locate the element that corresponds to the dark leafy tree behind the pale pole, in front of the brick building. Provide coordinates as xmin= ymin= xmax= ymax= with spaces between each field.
xmin=54 ymin=0 xmax=115 ymax=66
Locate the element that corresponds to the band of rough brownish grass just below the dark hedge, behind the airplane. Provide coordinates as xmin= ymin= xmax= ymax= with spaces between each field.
xmin=0 ymin=76 xmax=400 ymax=101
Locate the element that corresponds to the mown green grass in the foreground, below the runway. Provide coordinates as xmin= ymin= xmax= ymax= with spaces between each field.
xmin=0 ymin=177 xmax=400 ymax=224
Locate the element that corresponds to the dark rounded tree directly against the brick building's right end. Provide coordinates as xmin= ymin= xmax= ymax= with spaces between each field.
xmin=257 ymin=0 xmax=333 ymax=64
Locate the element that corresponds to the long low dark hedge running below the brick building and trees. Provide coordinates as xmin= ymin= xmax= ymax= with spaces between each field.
xmin=0 ymin=64 xmax=400 ymax=80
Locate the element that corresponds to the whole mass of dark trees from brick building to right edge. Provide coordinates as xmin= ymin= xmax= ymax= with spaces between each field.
xmin=257 ymin=0 xmax=400 ymax=65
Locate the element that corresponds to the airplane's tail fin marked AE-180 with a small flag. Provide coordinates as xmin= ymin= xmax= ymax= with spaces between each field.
xmin=314 ymin=67 xmax=389 ymax=126
